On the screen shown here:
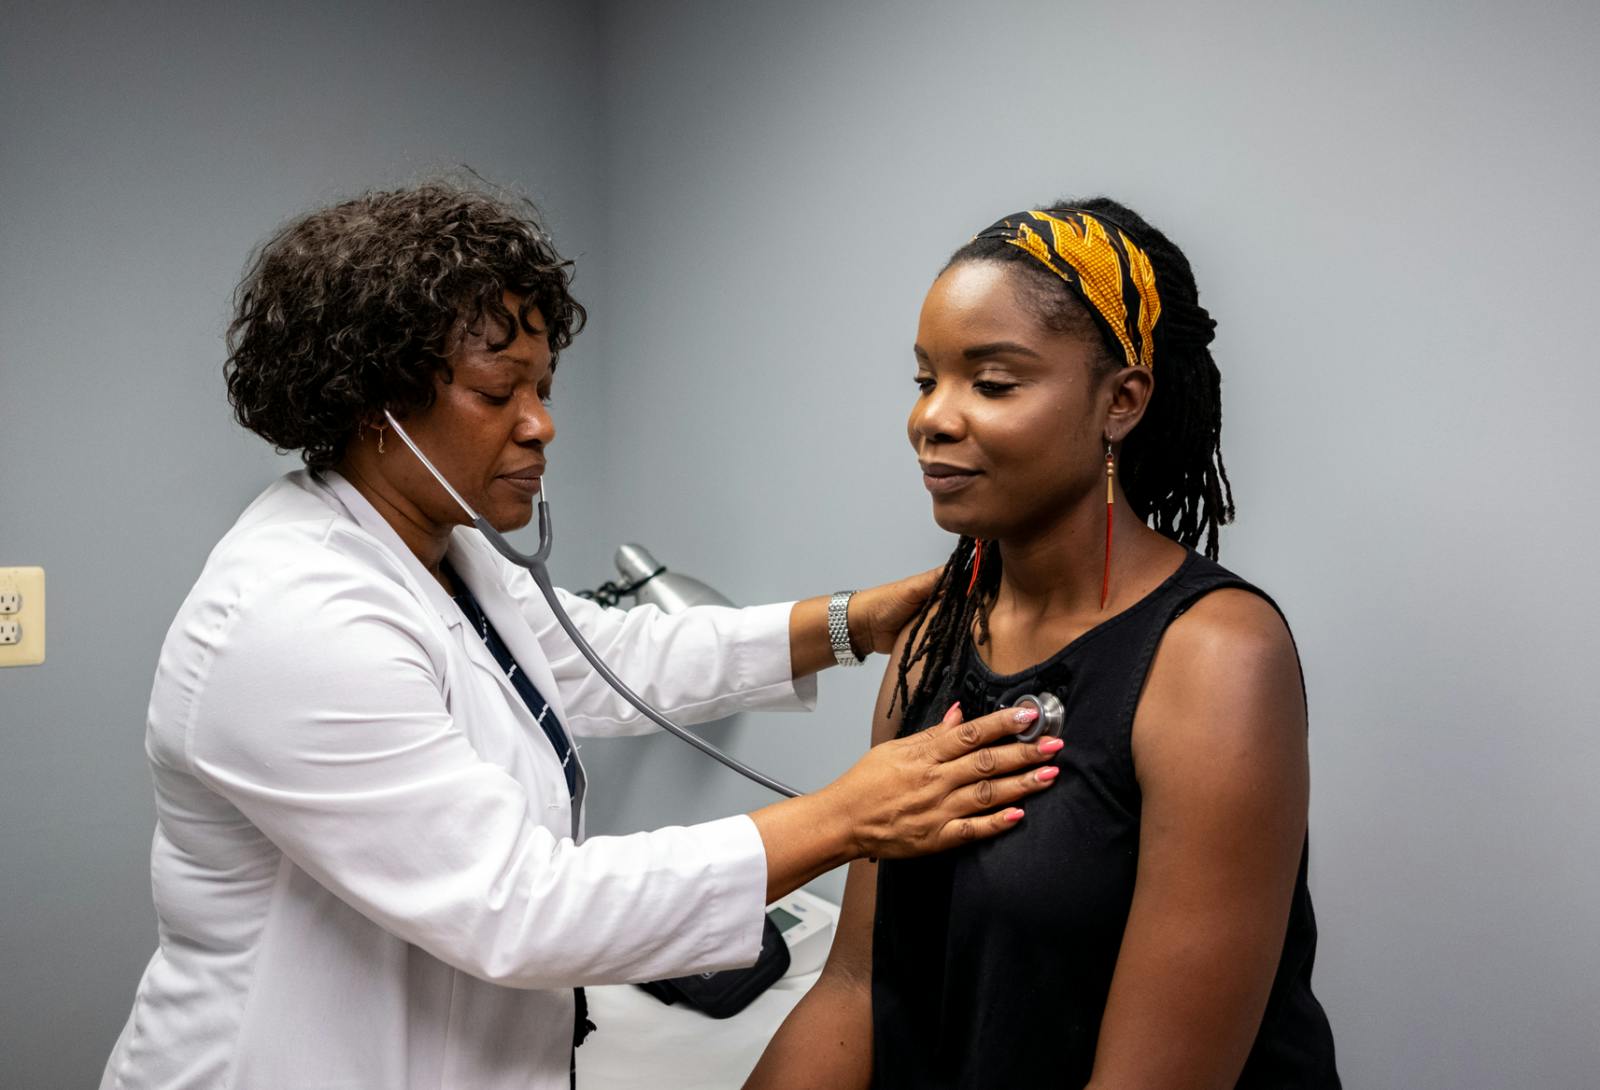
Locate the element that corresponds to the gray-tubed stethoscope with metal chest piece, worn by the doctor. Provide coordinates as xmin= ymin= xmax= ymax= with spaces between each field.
xmin=384 ymin=410 xmax=1066 ymax=799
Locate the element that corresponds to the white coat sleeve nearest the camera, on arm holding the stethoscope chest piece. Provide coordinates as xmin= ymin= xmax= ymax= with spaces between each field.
xmin=182 ymin=565 xmax=766 ymax=988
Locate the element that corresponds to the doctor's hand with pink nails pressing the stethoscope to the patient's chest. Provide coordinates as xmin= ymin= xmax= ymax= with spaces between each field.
xmin=750 ymin=707 xmax=1062 ymax=901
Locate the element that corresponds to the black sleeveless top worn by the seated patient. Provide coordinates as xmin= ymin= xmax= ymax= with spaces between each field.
xmin=872 ymin=552 xmax=1339 ymax=1090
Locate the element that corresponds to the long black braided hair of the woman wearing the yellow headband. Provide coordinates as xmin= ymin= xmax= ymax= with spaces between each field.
xmin=890 ymin=197 xmax=1234 ymax=731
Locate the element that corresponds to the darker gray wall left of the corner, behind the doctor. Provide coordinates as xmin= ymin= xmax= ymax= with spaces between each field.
xmin=0 ymin=3 xmax=605 ymax=1090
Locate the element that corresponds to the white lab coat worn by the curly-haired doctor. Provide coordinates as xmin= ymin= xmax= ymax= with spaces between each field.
xmin=101 ymin=472 xmax=811 ymax=1090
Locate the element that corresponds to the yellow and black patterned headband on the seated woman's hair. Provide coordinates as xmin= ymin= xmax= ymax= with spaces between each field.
xmin=976 ymin=208 xmax=1162 ymax=367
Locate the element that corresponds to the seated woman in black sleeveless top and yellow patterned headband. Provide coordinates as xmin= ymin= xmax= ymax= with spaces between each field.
xmin=747 ymin=198 xmax=1339 ymax=1090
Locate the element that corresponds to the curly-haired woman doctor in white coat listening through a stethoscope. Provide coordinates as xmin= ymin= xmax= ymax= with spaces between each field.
xmin=101 ymin=186 xmax=1059 ymax=1090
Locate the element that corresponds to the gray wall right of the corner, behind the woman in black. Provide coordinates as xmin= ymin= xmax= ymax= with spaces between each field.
xmin=590 ymin=2 xmax=1600 ymax=1090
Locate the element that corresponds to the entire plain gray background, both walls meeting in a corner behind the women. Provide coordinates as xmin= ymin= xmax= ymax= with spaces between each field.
xmin=0 ymin=2 xmax=1600 ymax=1090
